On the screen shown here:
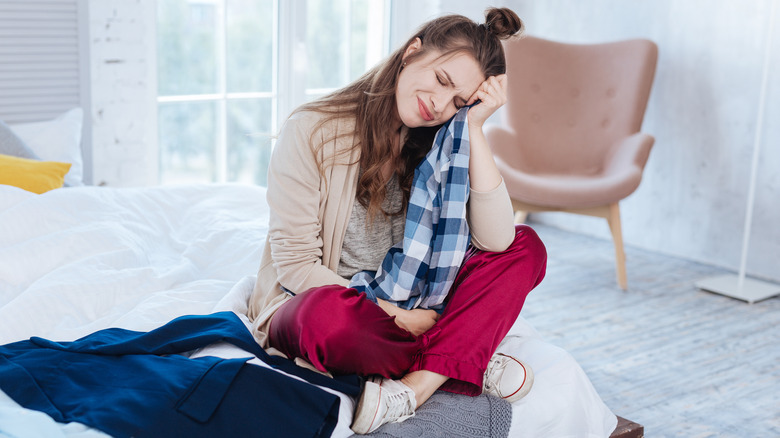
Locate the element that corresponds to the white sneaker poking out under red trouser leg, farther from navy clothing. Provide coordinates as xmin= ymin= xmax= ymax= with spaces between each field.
xmin=482 ymin=353 xmax=534 ymax=403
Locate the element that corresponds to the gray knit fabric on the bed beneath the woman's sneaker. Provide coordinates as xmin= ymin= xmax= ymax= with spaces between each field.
xmin=352 ymin=391 xmax=512 ymax=438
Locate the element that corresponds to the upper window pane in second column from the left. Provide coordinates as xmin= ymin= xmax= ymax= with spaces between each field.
xmin=225 ymin=0 xmax=274 ymax=93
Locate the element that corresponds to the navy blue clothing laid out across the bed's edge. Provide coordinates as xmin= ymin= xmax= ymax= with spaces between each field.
xmin=0 ymin=312 xmax=360 ymax=437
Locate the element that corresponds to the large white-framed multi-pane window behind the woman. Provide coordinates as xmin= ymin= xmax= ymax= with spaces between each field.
xmin=157 ymin=0 xmax=389 ymax=185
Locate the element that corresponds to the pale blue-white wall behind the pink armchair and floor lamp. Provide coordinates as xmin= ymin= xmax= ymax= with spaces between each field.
xmin=443 ymin=0 xmax=780 ymax=281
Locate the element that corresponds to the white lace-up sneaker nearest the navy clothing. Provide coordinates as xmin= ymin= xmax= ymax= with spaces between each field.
xmin=352 ymin=377 xmax=417 ymax=434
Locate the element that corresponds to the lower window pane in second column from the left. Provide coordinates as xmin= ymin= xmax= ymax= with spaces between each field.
xmin=227 ymin=99 xmax=272 ymax=186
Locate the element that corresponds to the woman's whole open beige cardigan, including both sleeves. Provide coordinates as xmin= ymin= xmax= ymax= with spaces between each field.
xmin=248 ymin=111 xmax=514 ymax=348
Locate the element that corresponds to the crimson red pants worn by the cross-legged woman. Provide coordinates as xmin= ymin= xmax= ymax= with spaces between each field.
xmin=269 ymin=225 xmax=547 ymax=395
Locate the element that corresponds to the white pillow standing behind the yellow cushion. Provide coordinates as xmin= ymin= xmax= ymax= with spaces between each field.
xmin=8 ymin=108 xmax=84 ymax=186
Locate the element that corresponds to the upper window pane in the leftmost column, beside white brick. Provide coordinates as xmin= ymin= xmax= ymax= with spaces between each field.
xmin=157 ymin=0 xmax=217 ymax=96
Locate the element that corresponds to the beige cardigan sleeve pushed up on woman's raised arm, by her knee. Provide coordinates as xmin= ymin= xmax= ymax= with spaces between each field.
xmin=466 ymin=179 xmax=515 ymax=252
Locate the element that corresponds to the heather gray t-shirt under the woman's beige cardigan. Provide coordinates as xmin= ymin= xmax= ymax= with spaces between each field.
xmin=336 ymin=175 xmax=406 ymax=278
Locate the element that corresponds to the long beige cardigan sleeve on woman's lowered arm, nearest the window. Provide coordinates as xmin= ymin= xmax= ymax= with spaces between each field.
xmin=267 ymin=112 xmax=349 ymax=293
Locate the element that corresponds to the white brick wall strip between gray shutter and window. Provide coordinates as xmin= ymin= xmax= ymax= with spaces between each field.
xmin=87 ymin=0 xmax=158 ymax=186
